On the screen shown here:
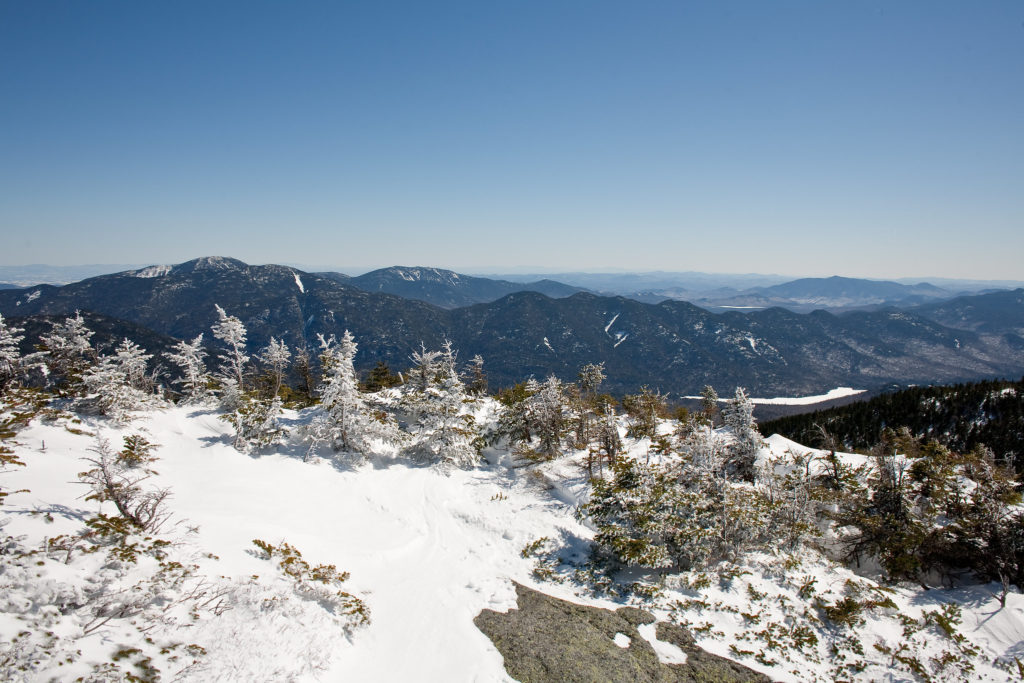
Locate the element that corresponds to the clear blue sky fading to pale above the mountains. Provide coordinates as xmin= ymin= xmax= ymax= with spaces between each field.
xmin=0 ymin=0 xmax=1024 ymax=279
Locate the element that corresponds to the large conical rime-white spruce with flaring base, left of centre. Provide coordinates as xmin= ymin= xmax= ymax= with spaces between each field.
xmin=314 ymin=330 xmax=393 ymax=456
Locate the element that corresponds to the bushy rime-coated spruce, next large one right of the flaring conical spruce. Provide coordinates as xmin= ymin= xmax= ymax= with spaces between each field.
xmin=406 ymin=342 xmax=479 ymax=467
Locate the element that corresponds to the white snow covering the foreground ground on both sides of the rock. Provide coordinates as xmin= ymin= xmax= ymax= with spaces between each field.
xmin=0 ymin=407 xmax=1024 ymax=681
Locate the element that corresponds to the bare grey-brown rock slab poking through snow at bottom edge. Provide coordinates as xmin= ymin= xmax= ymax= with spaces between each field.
xmin=473 ymin=584 xmax=771 ymax=683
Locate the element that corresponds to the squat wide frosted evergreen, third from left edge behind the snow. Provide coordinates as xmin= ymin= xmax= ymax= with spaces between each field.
xmin=82 ymin=339 xmax=158 ymax=422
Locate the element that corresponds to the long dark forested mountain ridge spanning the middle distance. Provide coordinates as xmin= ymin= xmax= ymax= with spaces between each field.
xmin=0 ymin=257 xmax=1024 ymax=395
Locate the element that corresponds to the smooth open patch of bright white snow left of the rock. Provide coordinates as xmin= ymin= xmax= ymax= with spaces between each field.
xmin=0 ymin=408 xmax=589 ymax=681
